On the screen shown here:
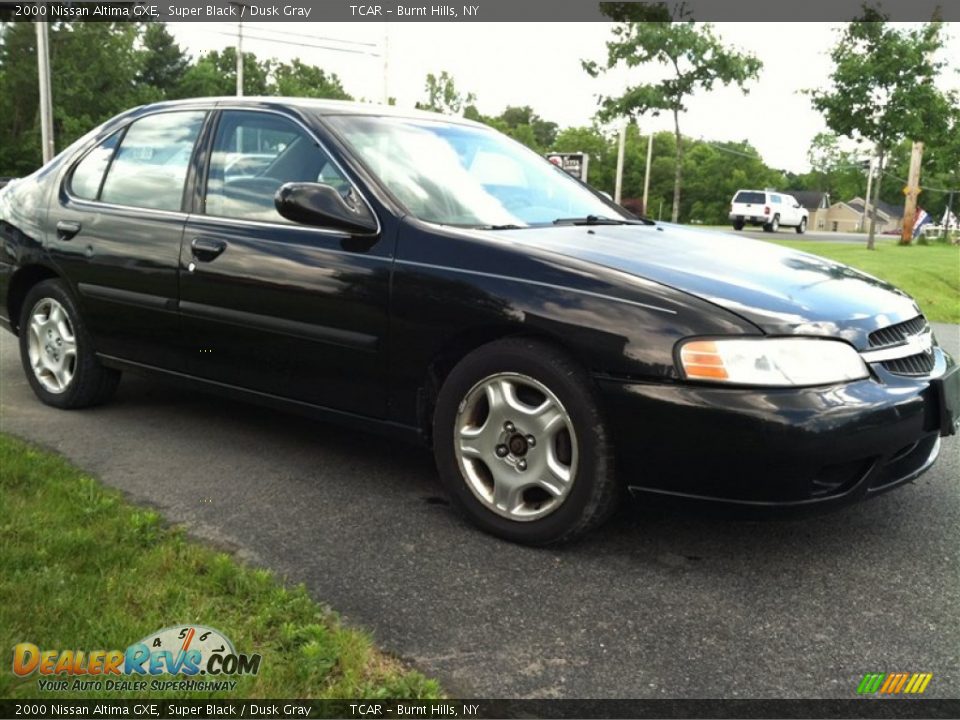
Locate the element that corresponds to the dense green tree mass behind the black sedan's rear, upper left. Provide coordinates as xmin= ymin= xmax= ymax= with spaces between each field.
xmin=0 ymin=22 xmax=360 ymax=176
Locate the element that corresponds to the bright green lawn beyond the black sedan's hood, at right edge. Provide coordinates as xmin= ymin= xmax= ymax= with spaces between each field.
xmin=769 ymin=240 xmax=960 ymax=323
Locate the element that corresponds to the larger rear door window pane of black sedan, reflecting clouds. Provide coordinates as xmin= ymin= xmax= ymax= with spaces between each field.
xmin=100 ymin=110 xmax=206 ymax=210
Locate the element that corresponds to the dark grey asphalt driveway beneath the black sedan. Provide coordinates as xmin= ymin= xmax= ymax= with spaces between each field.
xmin=0 ymin=326 xmax=960 ymax=698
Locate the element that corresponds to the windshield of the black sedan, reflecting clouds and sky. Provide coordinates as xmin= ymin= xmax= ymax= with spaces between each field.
xmin=327 ymin=115 xmax=627 ymax=227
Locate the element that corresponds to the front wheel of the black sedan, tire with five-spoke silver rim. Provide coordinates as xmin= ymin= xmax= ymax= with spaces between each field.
xmin=433 ymin=338 xmax=622 ymax=545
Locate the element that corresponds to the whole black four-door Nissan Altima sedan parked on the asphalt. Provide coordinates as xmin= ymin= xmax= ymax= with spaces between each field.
xmin=0 ymin=98 xmax=960 ymax=544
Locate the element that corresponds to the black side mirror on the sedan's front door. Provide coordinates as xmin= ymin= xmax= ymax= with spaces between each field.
xmin=273 ymin=183 xmax=379 ymax=235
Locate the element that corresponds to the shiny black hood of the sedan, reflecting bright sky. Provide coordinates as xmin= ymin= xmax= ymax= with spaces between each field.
xmin=496 ymin=224 xmax=920 ymax=348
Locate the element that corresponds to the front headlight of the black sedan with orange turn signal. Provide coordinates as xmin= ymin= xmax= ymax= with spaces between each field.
xmin=680 ymin=338 xmax=870 ymax=387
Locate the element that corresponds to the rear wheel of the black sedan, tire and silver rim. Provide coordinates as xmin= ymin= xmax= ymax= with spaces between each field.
xmin=19 ymin=280 xmax=120 ymax=410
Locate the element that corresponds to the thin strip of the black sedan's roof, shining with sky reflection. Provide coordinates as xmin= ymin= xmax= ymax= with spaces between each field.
xmin=138 ymin=95 xmax=487 ymax=127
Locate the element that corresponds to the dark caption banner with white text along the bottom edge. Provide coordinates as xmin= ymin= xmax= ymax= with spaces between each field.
xmin=0 ymin=698 xmax=960 ymax=720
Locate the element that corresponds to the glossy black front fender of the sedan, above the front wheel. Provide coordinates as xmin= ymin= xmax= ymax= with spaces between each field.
xmin=389 ymin=221 xmax=761 ymax=423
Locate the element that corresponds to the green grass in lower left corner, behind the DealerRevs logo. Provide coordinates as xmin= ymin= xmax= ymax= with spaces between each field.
xmin=0 ymin=434 xmax=441 ymax=699
